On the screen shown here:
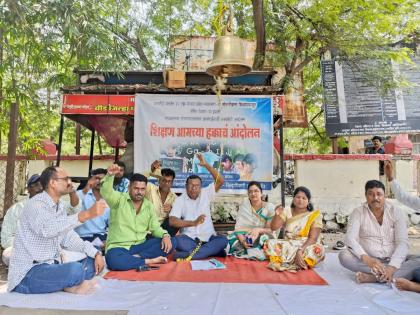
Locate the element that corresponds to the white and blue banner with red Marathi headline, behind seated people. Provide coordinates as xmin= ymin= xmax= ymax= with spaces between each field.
xmin=134 ymin=94 xmax=273 ymax=193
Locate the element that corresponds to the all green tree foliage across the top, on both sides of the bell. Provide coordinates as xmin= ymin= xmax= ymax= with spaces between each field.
xmin=0 ymin=0 xmax=420 ymax=153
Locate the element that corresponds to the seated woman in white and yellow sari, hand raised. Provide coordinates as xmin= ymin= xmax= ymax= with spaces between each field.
xmin=264 ymin=186 xmax=325 ymax=271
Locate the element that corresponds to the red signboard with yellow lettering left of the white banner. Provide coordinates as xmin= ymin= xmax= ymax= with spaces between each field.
xmin=61 ymin=94 xmax=134 ymax=115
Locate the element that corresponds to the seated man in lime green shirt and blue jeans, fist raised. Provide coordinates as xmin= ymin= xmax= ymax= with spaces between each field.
xmin=101 ymin=164 xmax=176 ymax=270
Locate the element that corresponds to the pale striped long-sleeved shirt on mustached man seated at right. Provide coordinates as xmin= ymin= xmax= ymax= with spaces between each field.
xmin=346 ymin=201 xmax=408 ymax=268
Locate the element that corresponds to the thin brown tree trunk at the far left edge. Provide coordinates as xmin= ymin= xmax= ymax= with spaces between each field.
xmin=3 ymin=103 xmax=19 ymax=215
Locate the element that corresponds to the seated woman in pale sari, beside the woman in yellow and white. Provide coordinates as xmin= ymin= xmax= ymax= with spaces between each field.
xmin=228 ymin=181 xmax=274 ymax=260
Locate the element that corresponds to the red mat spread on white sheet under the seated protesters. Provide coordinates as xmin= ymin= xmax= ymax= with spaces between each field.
xmin=104 ymin=257 xmax=328 ymax=285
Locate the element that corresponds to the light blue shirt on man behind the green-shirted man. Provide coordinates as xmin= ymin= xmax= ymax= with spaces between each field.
xmin=75 ymin=189 xmax=110 ymax=237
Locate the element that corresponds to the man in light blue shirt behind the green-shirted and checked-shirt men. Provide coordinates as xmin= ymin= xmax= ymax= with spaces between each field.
xmin=70 ymin=168 xmax=110 ymax=247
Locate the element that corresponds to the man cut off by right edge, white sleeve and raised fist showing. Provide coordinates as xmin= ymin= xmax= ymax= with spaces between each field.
xmin=385 ymin=161 xmax=420 ymax=293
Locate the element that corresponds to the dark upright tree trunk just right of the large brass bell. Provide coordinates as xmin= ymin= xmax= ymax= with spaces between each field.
xmin=252 ymin=0 xmax=265 ymax=70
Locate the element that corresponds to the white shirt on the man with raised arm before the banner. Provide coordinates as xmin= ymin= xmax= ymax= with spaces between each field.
xmin=170 ymin=183 xmax=216 ymax=242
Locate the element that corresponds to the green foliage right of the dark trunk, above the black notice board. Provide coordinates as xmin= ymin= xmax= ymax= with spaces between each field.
xmin=265 ymin=0 xmax=419 ymax=153
